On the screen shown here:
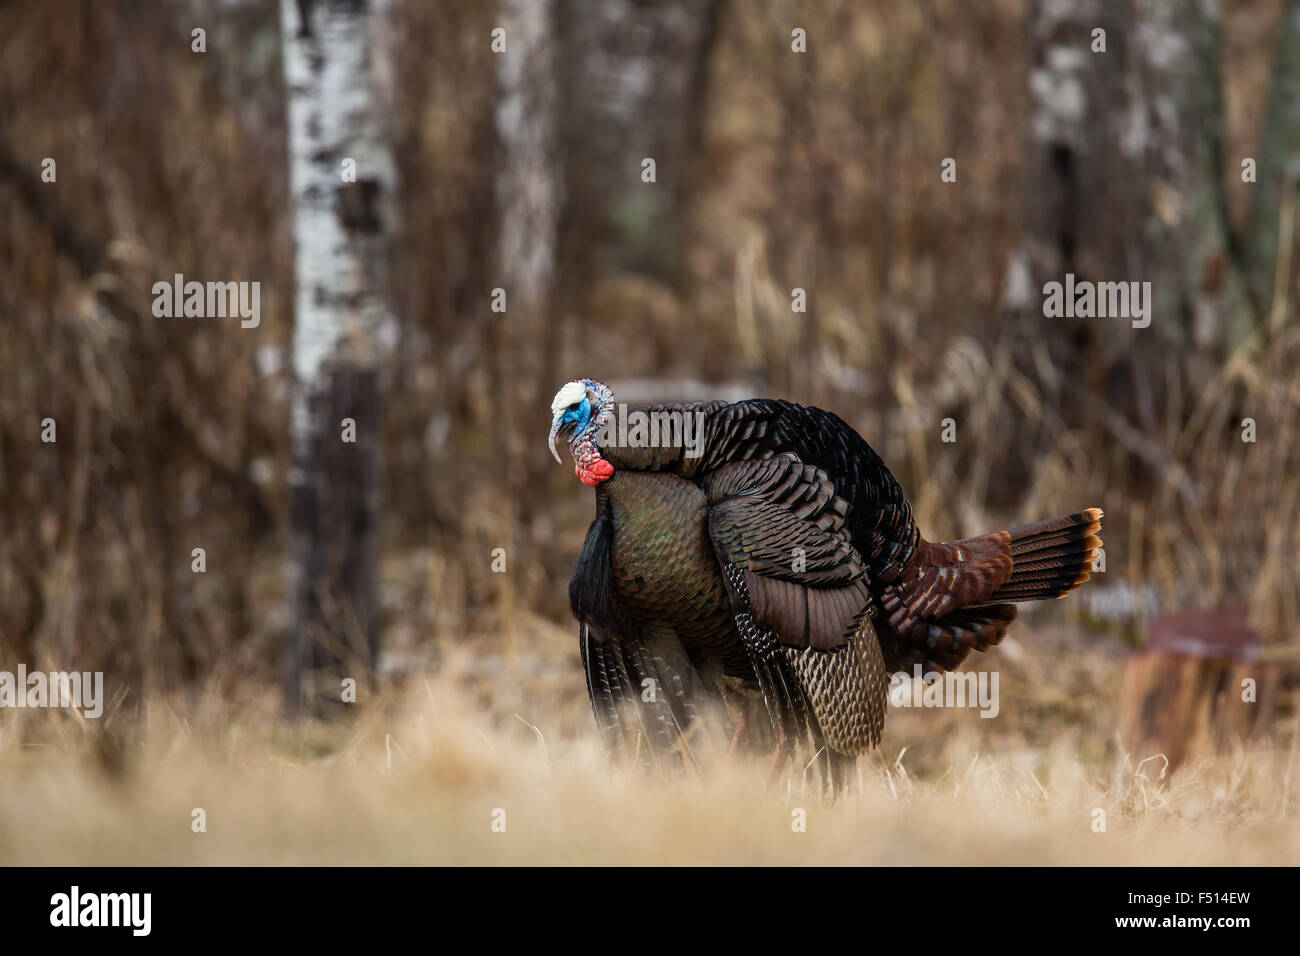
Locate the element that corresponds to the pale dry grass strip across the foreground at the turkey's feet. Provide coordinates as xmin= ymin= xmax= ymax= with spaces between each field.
xmin=0 ymin=631 xmax=1300 ymax=865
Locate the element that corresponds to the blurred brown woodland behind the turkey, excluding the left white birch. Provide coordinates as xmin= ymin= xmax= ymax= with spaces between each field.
xmin=0 ymin=0 xmax=1300 ymax=754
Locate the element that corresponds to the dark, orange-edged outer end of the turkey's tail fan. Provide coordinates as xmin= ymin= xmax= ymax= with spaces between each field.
xmin=989 ymin=507 xmax=1101 ymax=602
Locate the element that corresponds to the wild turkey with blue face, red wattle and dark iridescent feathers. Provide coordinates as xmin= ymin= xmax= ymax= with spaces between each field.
xmin=550 ymin=378 xmax=1101 ymax=786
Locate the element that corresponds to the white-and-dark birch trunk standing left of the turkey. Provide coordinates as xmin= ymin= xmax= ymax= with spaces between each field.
xmin=281 ymin=0 xmax=394 ymax=711
